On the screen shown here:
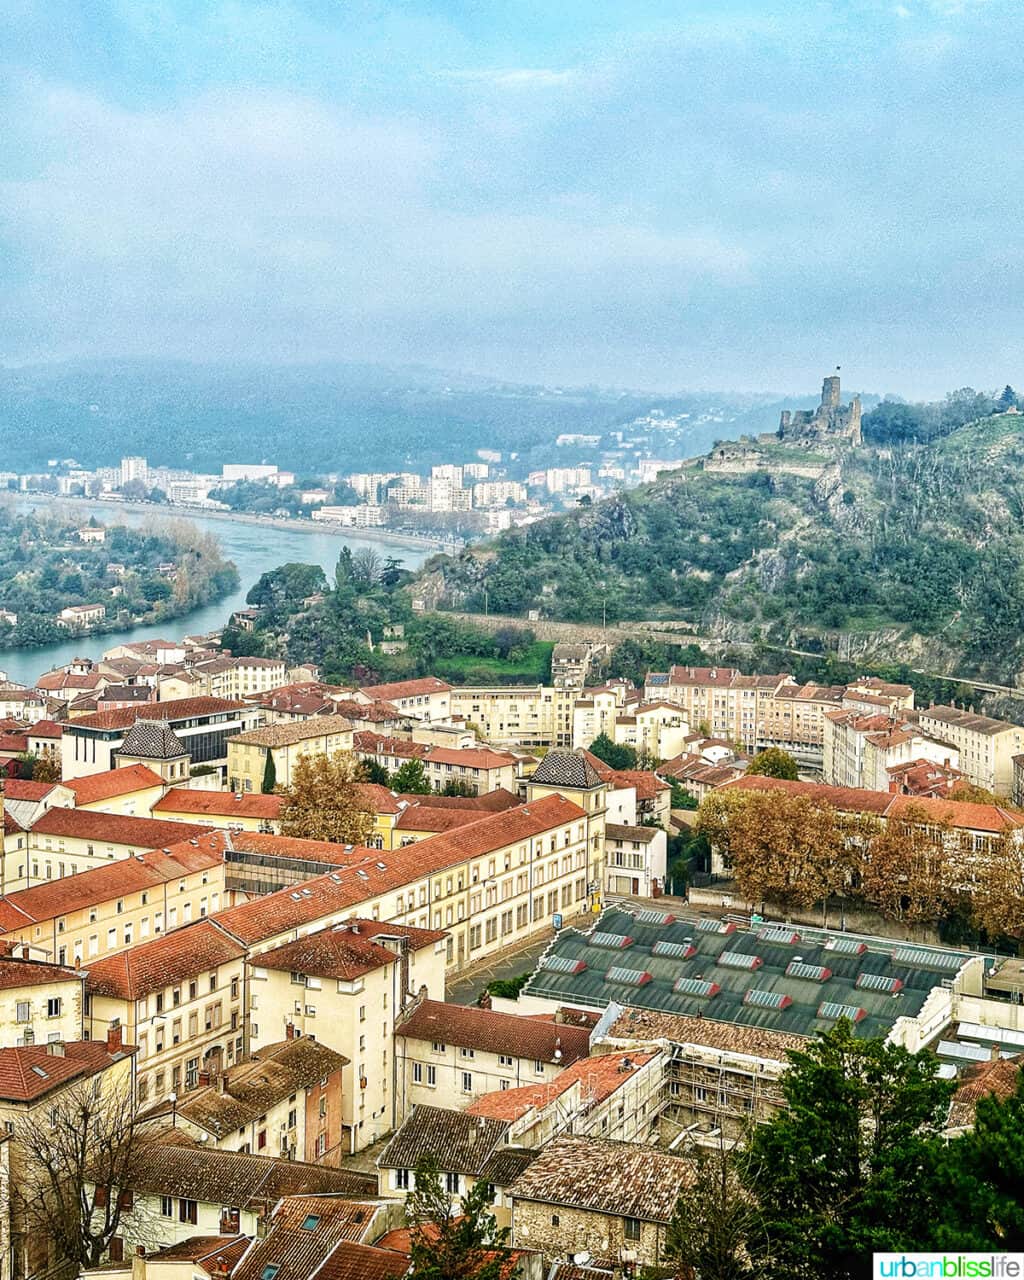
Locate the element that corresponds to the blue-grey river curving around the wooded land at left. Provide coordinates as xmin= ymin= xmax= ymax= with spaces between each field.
xmin=0 ymin=498 xmax=434 ymax=686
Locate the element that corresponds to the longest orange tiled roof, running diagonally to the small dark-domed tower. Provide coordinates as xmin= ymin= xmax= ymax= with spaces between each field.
xmin=216 ymin=795 xmax=585 ymax=945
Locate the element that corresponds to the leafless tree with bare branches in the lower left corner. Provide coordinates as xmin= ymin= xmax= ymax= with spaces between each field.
xmin=12 ymin=1076 xmax=152 ymax=1275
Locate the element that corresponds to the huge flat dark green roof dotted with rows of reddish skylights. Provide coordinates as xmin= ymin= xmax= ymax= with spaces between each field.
xmin=525 ymin=908 xmax=972 ymax=1036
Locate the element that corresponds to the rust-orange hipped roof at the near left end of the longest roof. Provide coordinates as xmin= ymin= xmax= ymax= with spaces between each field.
xmin=86 ymin=920 xmax=246 ymax=1000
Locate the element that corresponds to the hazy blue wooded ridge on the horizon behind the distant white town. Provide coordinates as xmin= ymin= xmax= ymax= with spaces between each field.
xmin=0 ymin=360 xmax=774 ymax=474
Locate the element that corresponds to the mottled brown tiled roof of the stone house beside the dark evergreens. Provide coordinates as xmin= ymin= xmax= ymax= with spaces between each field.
xmin=509 ymin=1138 xmax=694 ymax=1222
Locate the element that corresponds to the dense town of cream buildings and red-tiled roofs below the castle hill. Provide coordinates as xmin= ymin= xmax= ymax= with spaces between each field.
xmin=0 ymin=501 xmax=1024 ymax=1280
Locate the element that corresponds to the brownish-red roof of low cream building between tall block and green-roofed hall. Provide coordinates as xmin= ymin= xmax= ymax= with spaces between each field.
xmin=394 ymin=1000 xmax=590 ymax=1066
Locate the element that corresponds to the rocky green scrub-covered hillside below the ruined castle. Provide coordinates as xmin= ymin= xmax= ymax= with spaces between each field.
xmin=416 ymin=413 xmax=1024 ymax=684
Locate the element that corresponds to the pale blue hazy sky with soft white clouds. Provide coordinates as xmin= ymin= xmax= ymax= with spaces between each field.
xmin=0 ymin=0 xmax=1024 ymax=394
